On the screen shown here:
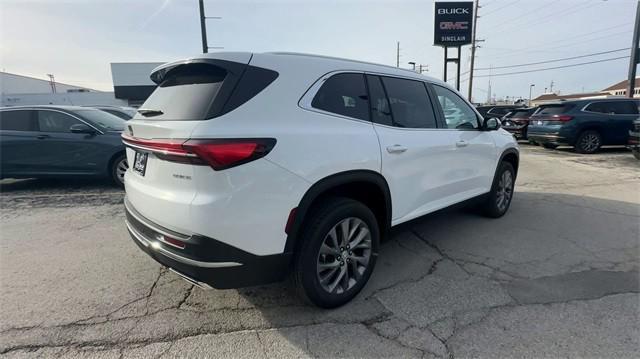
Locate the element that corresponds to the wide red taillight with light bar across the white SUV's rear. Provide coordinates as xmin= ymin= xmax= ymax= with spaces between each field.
xmin=122 ymin=134 xmax=276 ymax=171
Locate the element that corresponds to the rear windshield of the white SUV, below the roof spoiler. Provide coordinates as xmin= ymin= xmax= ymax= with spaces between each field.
xmin=136 ymin=64 xmax=227 ymax=121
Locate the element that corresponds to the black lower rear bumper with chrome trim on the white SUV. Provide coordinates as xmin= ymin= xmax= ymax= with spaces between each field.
xmin=125 ymin=199 xmax=292 ymax=289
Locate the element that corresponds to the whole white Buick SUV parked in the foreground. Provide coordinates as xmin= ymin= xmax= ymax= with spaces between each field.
xmin=123 ymin=53 xmax=518 ymax=308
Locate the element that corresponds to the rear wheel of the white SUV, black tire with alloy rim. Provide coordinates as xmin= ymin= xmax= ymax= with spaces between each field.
xmin=293 ymin=197 xmax=380 ymax=308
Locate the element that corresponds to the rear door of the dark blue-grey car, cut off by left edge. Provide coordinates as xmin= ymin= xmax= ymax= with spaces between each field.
xmin=0 ymin=109 xmax=42 ymax=178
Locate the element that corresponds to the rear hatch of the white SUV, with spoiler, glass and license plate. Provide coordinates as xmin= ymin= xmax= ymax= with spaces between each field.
xmin=122 ymin=53 xmax=277 ymax=229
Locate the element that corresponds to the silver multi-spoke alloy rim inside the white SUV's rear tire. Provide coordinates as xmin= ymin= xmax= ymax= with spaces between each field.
xmin=316 ymin=217 xmax=372 ymax=294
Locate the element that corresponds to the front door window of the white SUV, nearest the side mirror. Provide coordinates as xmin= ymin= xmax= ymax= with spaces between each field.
xmin=433 ymin=85 xmax=480 ymax=130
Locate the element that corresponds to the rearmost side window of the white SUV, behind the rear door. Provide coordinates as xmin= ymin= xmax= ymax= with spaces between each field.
xmin=311 ymin=73 xmax=369 ymax=121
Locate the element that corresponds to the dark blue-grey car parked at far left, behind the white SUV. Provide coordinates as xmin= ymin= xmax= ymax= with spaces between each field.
xmin=0 ymin=106 xmax=128 ymax=186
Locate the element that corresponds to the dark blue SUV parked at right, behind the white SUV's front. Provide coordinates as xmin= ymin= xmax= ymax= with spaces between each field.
xmin=528 ymin=98 xmax=640 ymax=153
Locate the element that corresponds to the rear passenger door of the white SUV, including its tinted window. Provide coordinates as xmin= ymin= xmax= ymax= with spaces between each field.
xmin=367 ymin=75 xmax=462 ymax=224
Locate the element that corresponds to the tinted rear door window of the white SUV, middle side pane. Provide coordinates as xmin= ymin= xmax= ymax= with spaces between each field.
xmin=382 ymin=77 xmax=436 ymax=128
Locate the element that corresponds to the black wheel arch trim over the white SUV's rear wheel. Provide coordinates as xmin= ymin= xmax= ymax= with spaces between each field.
xmin=284 ymin=170 xmax=391 ymax=253
